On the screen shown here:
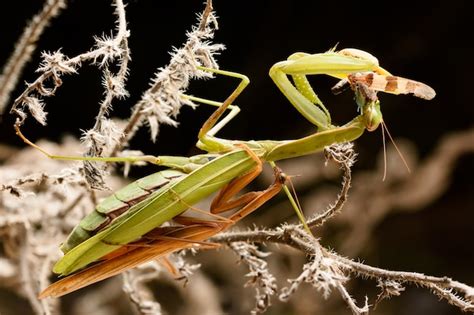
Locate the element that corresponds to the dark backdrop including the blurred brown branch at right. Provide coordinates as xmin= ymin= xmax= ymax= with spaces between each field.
xmin=0 ymin=0 xmax=474 ymax=315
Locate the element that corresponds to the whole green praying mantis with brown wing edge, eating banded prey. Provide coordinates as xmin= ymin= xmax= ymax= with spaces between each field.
xmin=12 ymin=49 xmax=435 ymax=298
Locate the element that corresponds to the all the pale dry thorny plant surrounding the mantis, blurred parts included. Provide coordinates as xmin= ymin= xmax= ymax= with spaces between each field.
xmin=0 ymin=0 xmax=474 ymax=314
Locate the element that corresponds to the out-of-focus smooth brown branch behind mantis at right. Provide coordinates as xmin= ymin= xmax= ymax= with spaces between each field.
xmin=330 ymin=129 xmax=474 ymax=256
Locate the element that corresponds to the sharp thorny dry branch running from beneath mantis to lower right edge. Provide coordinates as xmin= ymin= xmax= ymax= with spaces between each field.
xmin=211 ymin=222 xmax=474 ymax=314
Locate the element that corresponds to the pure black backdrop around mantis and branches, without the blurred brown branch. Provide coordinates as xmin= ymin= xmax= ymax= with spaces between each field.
xmin=0 ymin=0 xmax=474 ymax=314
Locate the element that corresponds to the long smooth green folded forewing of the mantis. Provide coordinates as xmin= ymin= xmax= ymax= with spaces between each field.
xmin=53 ymin=150 xmax=256 ymax=276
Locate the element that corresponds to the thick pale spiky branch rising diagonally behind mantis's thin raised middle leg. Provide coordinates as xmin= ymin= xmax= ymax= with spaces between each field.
xmin=112 ymin=0 xmax=224 ymax=155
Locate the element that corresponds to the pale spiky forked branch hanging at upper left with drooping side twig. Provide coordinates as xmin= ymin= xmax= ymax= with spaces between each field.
xmin=10 ymin=0 xmax=130 ymax=188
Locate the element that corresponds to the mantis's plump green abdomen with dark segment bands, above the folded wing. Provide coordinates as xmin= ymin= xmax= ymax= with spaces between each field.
xmin=61 ymin=170 xmax=186 ymax=253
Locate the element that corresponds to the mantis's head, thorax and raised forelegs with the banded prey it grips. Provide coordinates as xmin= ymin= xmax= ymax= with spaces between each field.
xmin=265 ymin=49 xmax=436 ymax=160
